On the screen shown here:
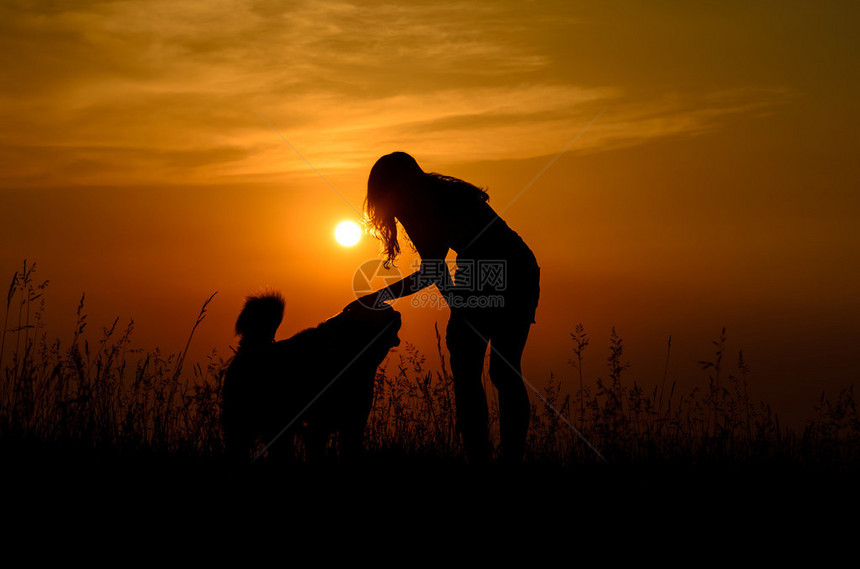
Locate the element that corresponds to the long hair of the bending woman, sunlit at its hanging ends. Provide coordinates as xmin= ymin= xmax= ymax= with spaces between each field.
xmin=364 ymin=152 xmax=490 ymax=268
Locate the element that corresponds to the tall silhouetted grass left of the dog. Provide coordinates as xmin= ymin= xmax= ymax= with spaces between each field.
xmin=0 ymin=263 xmax=224 ymax=454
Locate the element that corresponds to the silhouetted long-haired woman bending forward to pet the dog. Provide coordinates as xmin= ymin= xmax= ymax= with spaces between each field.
xmin=350 ymin=152 xmax=540 ymax=462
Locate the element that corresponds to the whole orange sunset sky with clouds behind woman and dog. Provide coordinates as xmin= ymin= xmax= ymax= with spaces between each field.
xmin=0 ymin=0 xmax=860 ymax=426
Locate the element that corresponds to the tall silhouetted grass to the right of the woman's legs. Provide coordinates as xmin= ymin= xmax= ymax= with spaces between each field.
xmin=530 ymin=325 xmax=860 ymax=469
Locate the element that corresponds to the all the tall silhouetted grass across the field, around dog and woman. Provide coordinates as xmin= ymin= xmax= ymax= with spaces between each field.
xmin=0 ymin=262 xmax=860 ymax=469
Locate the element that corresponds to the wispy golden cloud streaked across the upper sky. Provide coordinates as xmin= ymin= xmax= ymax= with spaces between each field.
xmin=0 ymin=0 xmax=792 ymax=186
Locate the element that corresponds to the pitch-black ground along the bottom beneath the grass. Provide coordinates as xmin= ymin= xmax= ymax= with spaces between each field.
xmin=0 ymin=447 xmax=860 ymax=567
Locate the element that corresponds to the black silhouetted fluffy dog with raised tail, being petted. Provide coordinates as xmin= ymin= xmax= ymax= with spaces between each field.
xmin=222 ymin=293 xmax=400 ymax=465
